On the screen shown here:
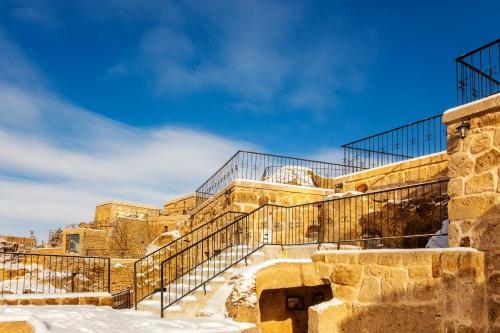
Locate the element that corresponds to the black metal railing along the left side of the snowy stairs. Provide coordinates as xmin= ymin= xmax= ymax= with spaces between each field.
xmin=134 ymin=212 xmax=245 ymax=308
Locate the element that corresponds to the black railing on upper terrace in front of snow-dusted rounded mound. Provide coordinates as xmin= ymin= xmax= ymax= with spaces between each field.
xmin=196 ymin=151 xmax=362 ymax=205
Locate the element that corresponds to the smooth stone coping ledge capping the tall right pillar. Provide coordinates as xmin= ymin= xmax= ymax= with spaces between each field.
xmin=443 ymin=93 xmax=500 ymax=125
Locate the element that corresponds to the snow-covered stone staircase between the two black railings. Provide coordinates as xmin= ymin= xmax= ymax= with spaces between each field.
xmin=137 ymin=245 xmax=266 ymax=318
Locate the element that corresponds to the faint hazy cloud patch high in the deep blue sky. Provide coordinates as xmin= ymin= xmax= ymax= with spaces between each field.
xmin=135 ymin=0 xmax=372 ymax=112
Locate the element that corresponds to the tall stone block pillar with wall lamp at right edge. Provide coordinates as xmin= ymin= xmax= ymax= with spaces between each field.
xmin=443 ymin=94 xmax=500 ymax=332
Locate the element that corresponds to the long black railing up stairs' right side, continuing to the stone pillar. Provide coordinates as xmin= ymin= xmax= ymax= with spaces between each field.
xmin=159 ymin=180 xmax=448 ymax=316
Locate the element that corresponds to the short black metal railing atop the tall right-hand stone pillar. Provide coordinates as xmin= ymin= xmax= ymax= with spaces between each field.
xmin=455 ymin=39 xmax=500 ymax=105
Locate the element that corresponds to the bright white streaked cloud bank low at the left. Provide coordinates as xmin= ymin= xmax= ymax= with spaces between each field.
xmin=0 ymin=32 xmax=251 ymax=237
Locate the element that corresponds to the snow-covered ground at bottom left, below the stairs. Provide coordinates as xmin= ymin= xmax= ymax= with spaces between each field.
xmin=0 ymin=305 xmax=253 ymax=333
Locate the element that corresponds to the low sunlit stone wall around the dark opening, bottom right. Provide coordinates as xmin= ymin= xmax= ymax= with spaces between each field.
xmin=236 ymin=248 xmax=488 ymax=333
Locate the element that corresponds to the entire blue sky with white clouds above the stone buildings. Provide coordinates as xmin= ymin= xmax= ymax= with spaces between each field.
xmin=0 ymin=0 xmax=500 ymax=237
